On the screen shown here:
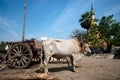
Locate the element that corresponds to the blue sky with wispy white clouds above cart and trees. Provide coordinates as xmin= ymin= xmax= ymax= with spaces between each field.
xmin=0 ymin=0 xmax=120 ymax=41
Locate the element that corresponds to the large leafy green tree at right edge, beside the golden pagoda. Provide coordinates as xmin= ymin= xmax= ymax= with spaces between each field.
xmin=98 ymin=15 xmax=120 ymax=45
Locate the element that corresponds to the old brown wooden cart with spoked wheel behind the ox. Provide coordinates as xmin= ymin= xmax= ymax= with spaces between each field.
xmin=5 ymin=39 xmax=41 ymax=68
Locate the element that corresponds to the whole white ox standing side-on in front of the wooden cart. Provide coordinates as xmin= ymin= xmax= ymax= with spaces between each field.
xmin=42 ymin=38 xmax=91 ymax=73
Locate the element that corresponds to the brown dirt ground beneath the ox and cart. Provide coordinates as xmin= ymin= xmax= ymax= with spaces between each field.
xmin=0 ymin=54 xmax=120 ymax=80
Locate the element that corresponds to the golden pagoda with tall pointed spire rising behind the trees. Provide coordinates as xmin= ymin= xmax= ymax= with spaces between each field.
xmin=88 ymin=3 xmax=108 ymax=46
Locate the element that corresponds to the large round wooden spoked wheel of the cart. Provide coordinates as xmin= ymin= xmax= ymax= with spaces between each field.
xmin=8 ymin=43 xmax=33 ymax=68
